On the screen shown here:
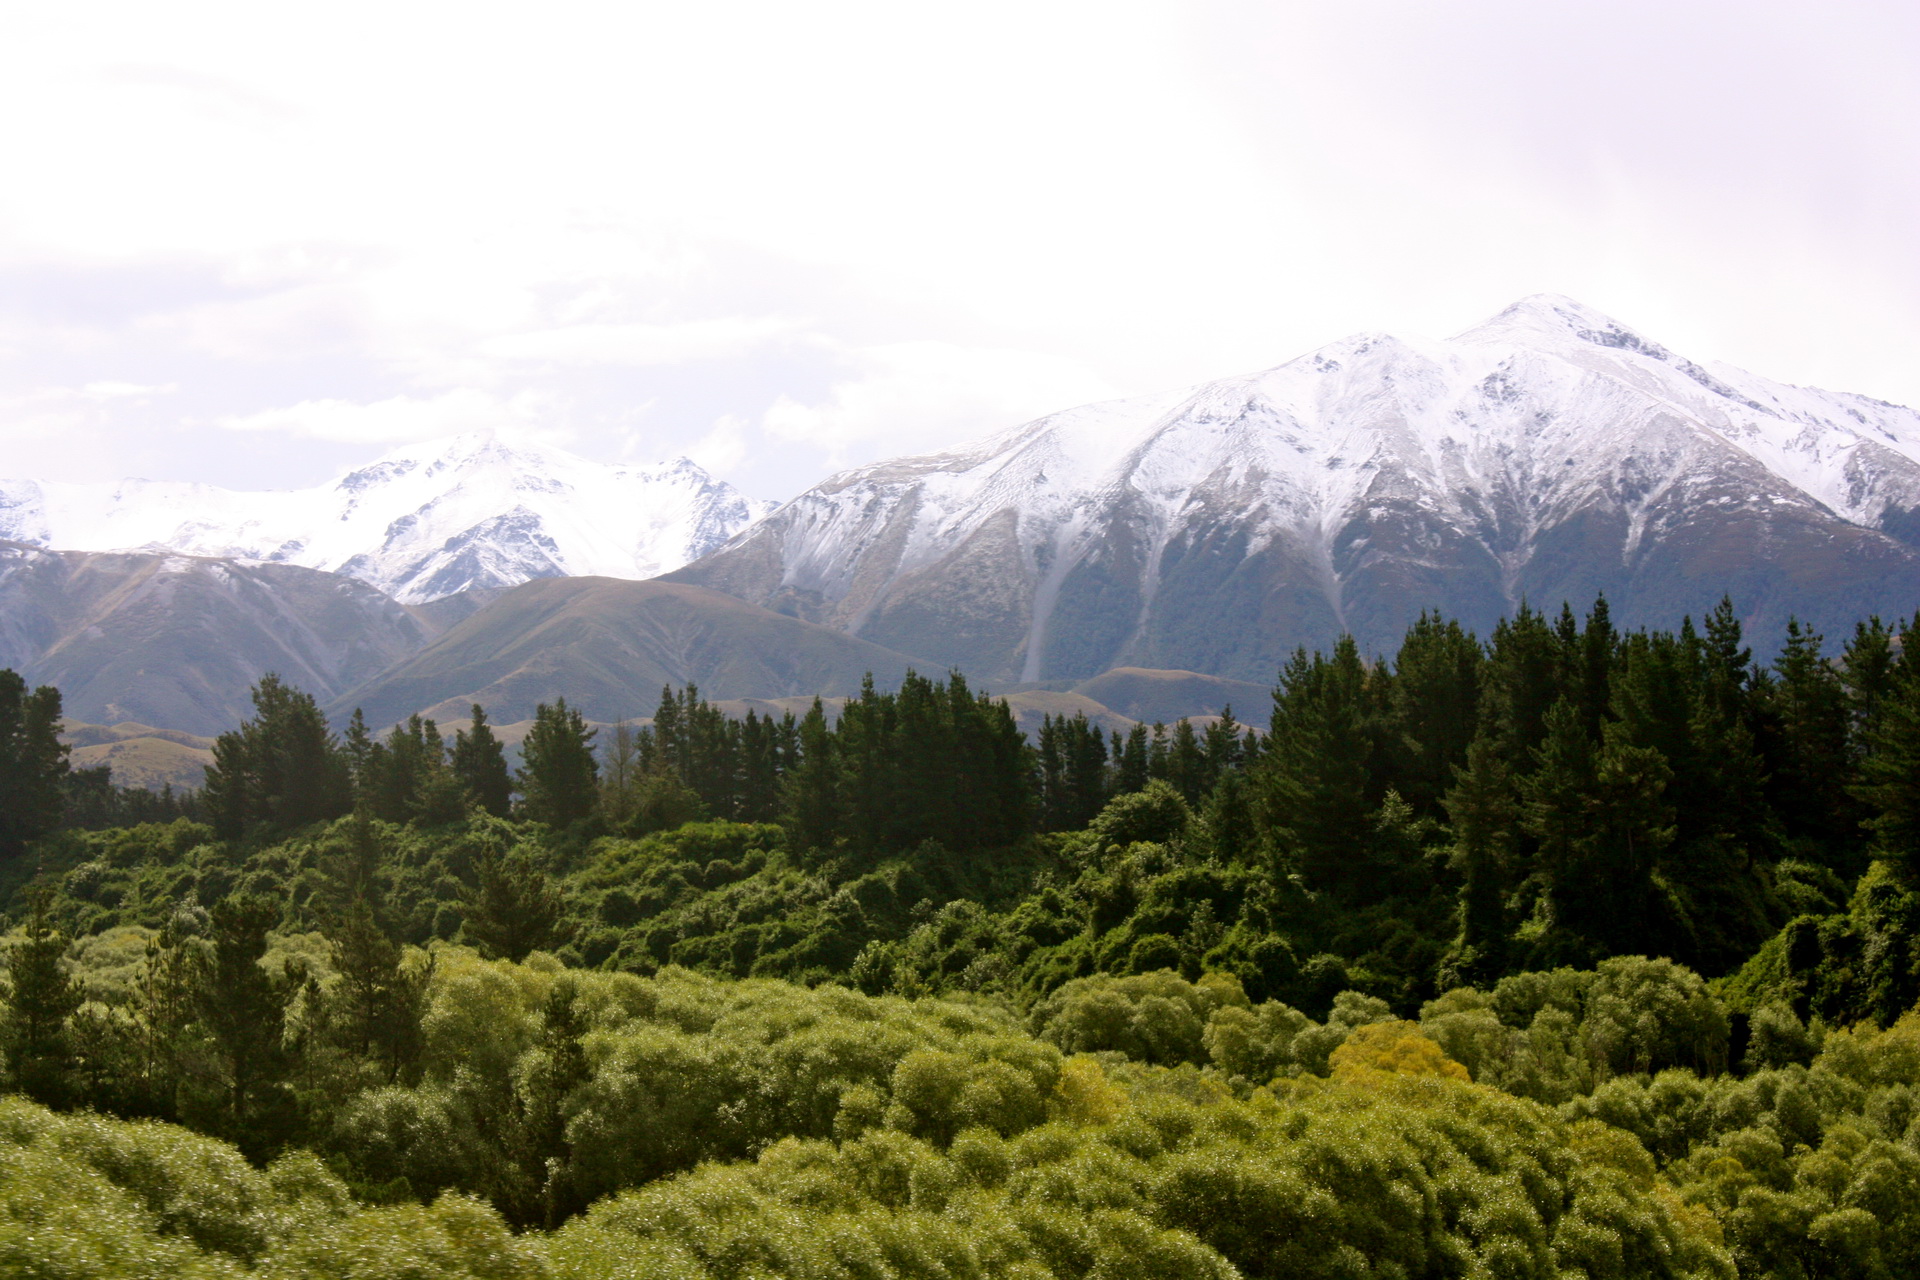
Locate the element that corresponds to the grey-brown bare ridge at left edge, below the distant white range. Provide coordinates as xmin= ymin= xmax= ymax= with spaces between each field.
xmin=0 ymin=541 xmax=432 ymax=735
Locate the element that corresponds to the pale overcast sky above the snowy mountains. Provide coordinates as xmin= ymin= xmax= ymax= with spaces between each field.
xmin=0 ymin=0 xmax=1920 ymax=499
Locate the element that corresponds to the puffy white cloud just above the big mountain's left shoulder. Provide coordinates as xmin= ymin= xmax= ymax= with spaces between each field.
xmin=764 ymin=342 xmax=1119 ymax=464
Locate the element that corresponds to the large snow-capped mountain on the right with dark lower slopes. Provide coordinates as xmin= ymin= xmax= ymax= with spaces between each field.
xmin=668 ymin=296 xmax=1920 ymax=679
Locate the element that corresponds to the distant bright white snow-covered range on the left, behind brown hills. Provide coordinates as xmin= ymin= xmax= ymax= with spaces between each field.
xmin=0 ymin=432 xmax=772 ymax=604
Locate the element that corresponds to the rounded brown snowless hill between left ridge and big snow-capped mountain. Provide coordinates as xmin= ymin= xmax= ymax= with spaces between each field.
xmin=332 ymin=578 xmax=939 ymax=725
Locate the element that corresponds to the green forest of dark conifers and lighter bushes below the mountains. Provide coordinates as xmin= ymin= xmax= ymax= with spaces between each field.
xmin=0 ymin=601 xmax=1920 ymax=1280
